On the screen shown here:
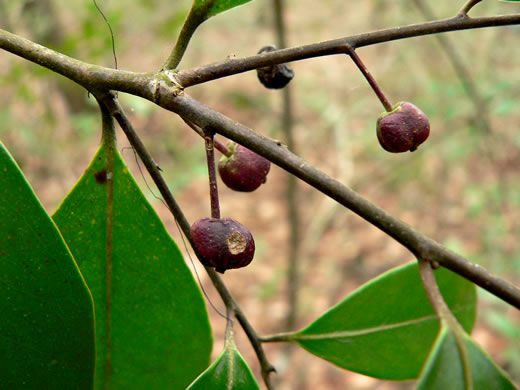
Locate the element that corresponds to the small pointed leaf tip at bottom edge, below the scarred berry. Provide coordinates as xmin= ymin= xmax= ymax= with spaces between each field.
xmin=187 ymin=331 xmax=260 ymax=390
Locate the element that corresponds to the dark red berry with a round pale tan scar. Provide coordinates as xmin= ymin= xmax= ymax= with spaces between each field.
xmin=190 ymin=218 xmax=255 ymax=273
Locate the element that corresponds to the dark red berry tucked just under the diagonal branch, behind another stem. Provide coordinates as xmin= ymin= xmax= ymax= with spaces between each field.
xmin=218 ymin=142 xmax=271 ymax=192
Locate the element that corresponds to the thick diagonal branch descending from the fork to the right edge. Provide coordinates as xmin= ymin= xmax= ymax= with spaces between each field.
xmin=162 ymin=94 xmax=520 ymax=309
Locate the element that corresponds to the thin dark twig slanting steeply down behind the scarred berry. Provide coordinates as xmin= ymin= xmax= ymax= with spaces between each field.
xmin=102 ymin=95 xmax=276 ymax=390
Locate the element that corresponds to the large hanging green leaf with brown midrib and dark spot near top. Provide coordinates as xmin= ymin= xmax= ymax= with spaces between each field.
xmin=54 ymin=145 xmax=212 ymax=390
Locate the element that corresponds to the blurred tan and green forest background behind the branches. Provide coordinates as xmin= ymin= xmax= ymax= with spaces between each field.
xmin=0 ymin=0 xmax=520 ymax=390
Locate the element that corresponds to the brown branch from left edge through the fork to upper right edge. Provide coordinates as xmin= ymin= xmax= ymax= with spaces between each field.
xmin=0 ymin=14 xmax=520 ymax=93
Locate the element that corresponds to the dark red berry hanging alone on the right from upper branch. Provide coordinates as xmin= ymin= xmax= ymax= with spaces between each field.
xmin=377 ymin=102 xmax=430 ymax=153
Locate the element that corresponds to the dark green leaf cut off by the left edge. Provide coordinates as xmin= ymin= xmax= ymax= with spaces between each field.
xmin=0 ymin=142 xmax=95 ymax=390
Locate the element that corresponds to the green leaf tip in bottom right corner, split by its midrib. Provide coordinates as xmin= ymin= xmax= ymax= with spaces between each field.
xmin=417 ymin=327 xmax=516 ymax=390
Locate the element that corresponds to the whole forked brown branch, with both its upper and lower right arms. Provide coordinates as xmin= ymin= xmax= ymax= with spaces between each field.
xmin=0 ymin=3 xmax=520 ymax=308
